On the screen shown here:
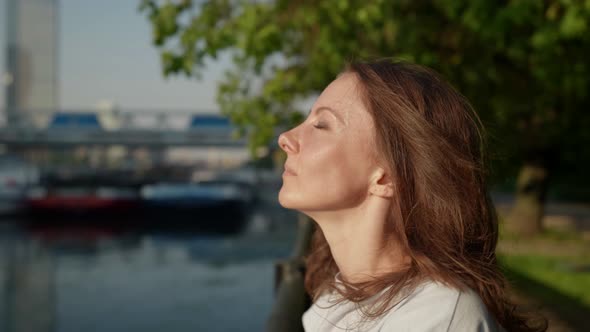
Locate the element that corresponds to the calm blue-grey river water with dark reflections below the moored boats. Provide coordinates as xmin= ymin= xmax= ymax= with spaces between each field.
xmin=0 ymin=206 xmax=296 ymax=332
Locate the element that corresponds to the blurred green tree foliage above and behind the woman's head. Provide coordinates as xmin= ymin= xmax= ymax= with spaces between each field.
xmin=140 ymin=0 xmax=590 ymax=233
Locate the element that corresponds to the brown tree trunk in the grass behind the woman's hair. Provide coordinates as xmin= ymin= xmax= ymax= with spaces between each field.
xmin=506 ymin=163 xmax=549 ymax=236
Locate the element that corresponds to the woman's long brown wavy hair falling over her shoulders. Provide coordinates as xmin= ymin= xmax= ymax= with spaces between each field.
xmin=305 ymin=59 xmax=547 ymax=331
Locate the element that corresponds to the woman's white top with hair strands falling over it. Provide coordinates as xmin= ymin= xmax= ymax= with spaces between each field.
xmin=302 ymin=277 xmax=504 ymax=332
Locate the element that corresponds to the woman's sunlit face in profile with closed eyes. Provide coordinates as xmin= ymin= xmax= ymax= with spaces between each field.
xmin=279 ymin=73 xmax=375 ymax=212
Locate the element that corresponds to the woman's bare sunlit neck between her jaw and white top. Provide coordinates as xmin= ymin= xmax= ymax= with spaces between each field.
xmin=305 ymin=196 xmax=407 ymax=282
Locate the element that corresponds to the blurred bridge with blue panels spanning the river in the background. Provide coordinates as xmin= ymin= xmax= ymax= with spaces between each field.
xmin=0 ymin=111 xmax=247 ymax=148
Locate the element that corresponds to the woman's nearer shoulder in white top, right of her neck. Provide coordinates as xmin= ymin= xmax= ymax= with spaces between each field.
xmin=381 ymin=282 xmax=501 ymax=332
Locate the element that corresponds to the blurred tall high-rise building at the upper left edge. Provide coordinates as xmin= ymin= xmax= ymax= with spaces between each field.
xmin=4 ymin=0 xmax=59 ymax=126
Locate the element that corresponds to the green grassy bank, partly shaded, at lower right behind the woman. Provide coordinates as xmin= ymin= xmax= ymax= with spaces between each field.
xmin=498 ymin=231 xmax=590 ymax=331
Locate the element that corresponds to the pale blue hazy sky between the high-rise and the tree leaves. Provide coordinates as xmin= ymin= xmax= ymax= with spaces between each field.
xmin=0 ymin=0 xmax=230 ymax=113
